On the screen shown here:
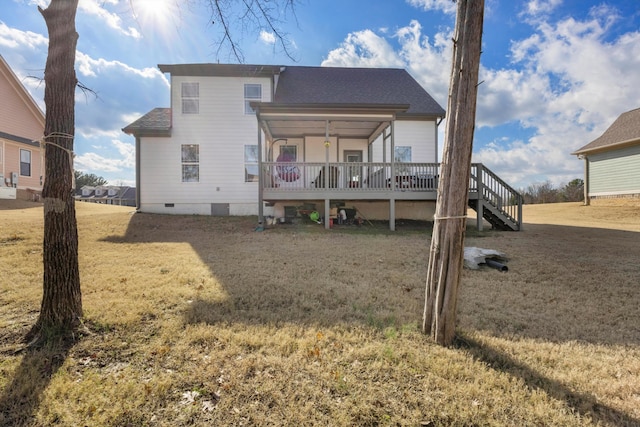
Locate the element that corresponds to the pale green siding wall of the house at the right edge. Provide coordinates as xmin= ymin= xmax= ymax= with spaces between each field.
xmin=588 ymin=145 xmax=640 ymax=196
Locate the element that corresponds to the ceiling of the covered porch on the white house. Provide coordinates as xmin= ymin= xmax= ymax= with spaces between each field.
xmin=252 ymin=103 xmax=409 ymax=142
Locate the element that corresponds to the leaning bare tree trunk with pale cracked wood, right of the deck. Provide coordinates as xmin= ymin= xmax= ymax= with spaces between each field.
xmin=422 ymin=0 xmax=484 ymax=345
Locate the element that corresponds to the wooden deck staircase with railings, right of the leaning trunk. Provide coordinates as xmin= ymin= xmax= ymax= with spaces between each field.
xmin=469 ymin=163 xmax=522 ymax=231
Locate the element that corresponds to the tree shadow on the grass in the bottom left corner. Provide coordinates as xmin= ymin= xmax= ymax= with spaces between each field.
xmin=0 ymin=339 xmax=75 ymax=427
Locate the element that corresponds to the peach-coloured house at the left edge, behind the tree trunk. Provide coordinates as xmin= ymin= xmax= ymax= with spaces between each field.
xmin=0 ymin=56 xmax=45 ymax=200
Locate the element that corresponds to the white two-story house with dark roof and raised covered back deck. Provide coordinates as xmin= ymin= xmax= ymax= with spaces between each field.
xmin=123 ymin=64 xmax=513 ymax=229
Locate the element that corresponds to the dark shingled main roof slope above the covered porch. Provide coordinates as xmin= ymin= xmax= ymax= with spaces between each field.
xmin=274 ymin=66 xmax=445 ymax=117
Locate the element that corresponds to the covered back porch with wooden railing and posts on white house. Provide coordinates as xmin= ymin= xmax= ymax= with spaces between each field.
xmin=251 ymin=103 xmax=428 ymax=229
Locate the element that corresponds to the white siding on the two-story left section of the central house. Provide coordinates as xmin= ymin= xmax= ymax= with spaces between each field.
xmin=140 ymin=76 xmax=271 ymax=215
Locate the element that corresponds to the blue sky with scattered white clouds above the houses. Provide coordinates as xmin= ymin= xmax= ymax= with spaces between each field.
xmin=0 ymin=0 xmax=640 ymax=188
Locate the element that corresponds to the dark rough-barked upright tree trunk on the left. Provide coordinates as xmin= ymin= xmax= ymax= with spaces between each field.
xmin=30 ymin=0 xmax=82 ymax=337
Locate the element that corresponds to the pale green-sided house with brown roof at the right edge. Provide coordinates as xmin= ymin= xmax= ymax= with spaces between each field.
xmin=571 ymin=108 xmax=640 ymax=204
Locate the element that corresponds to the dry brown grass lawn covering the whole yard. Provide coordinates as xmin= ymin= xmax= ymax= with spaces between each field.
xmin=0 ymin=201 xmax=640 ymax=426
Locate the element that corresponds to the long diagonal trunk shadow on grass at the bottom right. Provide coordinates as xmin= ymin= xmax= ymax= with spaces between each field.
xmin=455 ymin=336 xmax=640 ymax=427
